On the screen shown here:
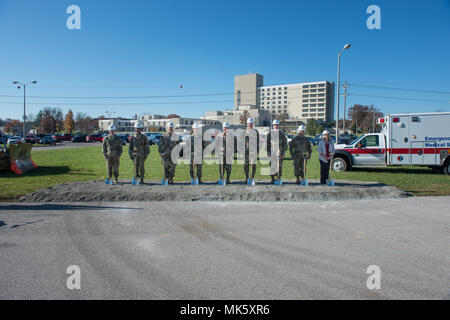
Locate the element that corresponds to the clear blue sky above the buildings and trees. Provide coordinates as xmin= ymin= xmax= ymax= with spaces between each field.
xmin=0 ymin=0 xmax=450 ymax=118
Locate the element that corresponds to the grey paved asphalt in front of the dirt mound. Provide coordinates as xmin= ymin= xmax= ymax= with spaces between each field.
xmin=0 ymin=197 xmax=450 ymax=299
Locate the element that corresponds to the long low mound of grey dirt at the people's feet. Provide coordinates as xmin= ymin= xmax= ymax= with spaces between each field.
xmin=20 ymin=180 xmax=407 ymax=202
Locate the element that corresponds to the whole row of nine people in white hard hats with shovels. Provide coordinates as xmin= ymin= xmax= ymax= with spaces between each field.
xmin=103 ymin=118 xmax=334 ymax=184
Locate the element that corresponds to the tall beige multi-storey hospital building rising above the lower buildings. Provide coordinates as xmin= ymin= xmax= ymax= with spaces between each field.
xmin=234 ymin=74 xmax=334 ymax=123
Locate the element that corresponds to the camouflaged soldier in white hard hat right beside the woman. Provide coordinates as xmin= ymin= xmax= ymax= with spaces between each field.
xmin=289 ymin=126 xmax=312 ymax=184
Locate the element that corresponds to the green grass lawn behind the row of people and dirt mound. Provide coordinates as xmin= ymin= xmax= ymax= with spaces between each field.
xmin=0 ymin=146 xmax=450 ymax=201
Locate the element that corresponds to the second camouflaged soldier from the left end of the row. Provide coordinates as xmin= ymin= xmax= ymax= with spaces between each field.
xmin=128 ymin=123 xmax=150 ymax=183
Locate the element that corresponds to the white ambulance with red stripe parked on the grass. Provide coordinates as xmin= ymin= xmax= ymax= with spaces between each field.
xmin=333 ymin=112 xmax=450 ymax=175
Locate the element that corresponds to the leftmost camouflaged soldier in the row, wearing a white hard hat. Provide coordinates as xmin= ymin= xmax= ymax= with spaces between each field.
xmin=103 ymin=125 xmax=123 ymax=183
